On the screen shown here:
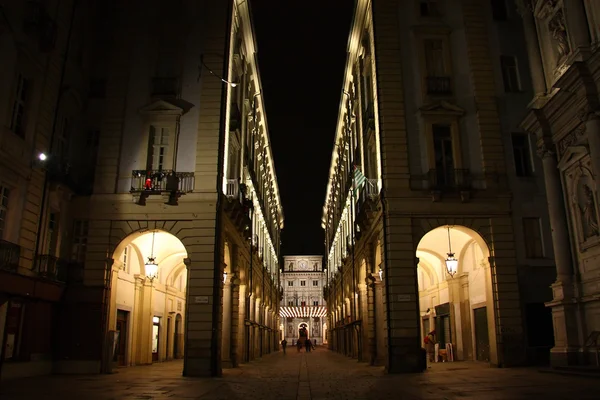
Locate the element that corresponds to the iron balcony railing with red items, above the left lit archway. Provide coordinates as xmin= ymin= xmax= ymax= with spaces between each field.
xmin=131 ymin=169 xmax=194 ymax=194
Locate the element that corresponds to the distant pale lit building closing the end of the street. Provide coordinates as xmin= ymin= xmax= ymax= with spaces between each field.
xmin=279 ymin=256 xmax=327 ymax=345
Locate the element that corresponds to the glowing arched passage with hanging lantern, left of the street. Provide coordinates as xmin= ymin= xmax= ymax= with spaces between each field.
xmin=109 ymin=230 xmax=187 ymax=366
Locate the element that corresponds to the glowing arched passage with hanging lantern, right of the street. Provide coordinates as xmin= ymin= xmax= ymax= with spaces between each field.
xmin=416 ymin=225 xmax=497 ymax=362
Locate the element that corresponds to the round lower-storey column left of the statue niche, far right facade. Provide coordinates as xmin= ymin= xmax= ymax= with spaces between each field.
xmin=538 ymin=144 xmax=573 ymax=284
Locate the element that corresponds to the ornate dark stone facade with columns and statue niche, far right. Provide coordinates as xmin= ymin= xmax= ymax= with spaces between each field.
xmin=519 ymin=0 xmax=600 ymax=365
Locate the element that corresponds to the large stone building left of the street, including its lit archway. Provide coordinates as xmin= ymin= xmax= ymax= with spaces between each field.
xmin=0 ymin=0 xmax=283 ymax=378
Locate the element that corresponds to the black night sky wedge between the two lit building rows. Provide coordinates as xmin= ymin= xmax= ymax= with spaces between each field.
xmin=251 ymin=0 xmax=354 ymax=255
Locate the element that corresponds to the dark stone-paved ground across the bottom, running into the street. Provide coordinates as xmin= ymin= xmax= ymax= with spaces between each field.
xmin=0 ymin=348 xmax=600 ymax=400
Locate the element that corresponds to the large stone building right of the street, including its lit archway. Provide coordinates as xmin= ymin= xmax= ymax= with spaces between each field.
xmin=322 ymin=0 xmax=556 ymax=372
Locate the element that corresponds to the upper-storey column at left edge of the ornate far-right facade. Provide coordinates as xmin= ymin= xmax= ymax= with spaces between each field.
xmin=517 ymin=0 xmax=546 ymax=97
